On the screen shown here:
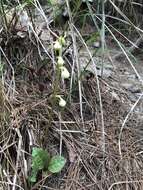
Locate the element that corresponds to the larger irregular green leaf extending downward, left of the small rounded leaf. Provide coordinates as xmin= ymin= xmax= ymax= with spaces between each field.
xmin=30 ymin=148 xmax=50 ymax=182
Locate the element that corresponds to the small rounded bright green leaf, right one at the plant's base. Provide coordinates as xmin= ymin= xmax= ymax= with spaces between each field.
xmin=48 ymin=156 xmax=66 ymax=173
